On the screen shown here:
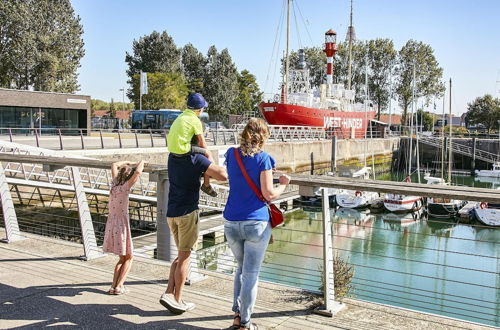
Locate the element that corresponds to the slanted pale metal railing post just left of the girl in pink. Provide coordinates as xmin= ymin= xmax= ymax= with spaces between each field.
xmin=71 ymin=166 xmax=102 ymax=260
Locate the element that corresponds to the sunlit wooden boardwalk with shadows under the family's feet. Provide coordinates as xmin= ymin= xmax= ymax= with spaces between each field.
xmin=0 ymin=228 xmax=491 ymax=330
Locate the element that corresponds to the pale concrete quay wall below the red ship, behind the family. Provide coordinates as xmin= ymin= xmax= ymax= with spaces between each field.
xmin=65 ymin=138 xmax=399 ymax=173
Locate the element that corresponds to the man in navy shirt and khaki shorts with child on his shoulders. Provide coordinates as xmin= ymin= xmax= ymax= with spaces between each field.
xmin=160 ymin=93 xmax=227 ymax=314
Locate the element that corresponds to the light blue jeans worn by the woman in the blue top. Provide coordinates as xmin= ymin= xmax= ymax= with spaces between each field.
xmin=224 ymin=220 xmax=271 ymax=326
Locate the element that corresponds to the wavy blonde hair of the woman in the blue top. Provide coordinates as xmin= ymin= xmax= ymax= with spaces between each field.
xmin=240 ymin=118 xmax=269 ymax=157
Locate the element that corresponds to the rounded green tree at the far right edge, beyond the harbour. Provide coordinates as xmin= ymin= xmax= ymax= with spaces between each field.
xmin=465 ymin=94 xmax=500 ymax=132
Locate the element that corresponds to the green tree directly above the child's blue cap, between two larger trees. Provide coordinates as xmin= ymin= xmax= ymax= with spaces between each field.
xmin=181 ymin=43 xmax=207 ymax=93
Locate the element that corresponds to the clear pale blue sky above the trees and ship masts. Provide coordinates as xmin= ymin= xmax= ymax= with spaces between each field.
xmin=71 ymin=0 xmax=500 ymax=114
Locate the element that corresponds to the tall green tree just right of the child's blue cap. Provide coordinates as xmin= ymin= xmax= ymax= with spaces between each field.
xmin=203 ymin=46 xmax=239 ymax=121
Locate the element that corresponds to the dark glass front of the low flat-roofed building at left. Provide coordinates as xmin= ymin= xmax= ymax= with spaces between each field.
xmin=0 ymin=106 xmax=87 ymax=129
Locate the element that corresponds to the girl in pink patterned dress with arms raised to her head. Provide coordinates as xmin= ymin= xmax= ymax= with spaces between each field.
xmin=103 ymin=160 xmax=144 ymax=295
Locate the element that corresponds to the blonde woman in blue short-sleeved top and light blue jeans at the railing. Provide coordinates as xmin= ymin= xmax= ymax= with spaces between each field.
xmin=224 ymin=118 xmax=290 ymax=329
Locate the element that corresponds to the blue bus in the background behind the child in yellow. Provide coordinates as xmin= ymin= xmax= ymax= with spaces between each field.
xmin=132 ymin=109 xmax=208 ymax=130
